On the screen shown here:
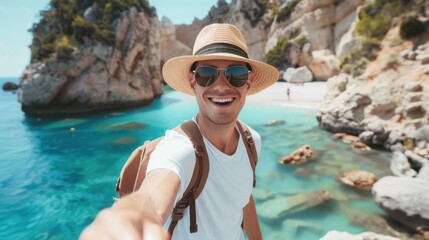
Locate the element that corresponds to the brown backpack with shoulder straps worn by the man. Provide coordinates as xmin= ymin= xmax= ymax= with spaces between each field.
xmin=116 ymin=121 xmax=258 ymax=236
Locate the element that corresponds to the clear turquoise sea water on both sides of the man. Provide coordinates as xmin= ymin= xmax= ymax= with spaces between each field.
xmin=0 ymin=79 xmax=390 ymax=240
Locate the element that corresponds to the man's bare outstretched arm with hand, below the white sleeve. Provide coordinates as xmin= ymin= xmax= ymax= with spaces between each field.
xmin=80 ymin=169 xmax=180 ymax=240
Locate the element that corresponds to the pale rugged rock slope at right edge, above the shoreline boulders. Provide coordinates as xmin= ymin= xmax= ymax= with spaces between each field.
xmin=318 ymin=28 xmax=429 ymax=150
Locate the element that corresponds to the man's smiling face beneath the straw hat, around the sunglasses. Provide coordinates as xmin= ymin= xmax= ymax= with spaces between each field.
xmin=189 ymin=60 xmax=252 ymax=125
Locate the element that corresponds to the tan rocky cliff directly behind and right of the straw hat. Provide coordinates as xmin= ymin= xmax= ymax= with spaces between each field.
xmin=166 ymin=0 xmax=365 ymax=81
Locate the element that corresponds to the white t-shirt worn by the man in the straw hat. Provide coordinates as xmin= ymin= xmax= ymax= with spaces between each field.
xmin=147 ymin=121 xmax=261 ymax=240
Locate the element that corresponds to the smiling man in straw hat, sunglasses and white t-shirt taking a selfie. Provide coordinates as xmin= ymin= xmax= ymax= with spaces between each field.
xmin=80 ymin=24 xmax=279 ymax=240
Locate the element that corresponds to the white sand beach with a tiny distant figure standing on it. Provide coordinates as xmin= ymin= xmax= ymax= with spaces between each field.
xmin=246 ymin=82 xmax=326 ymax=108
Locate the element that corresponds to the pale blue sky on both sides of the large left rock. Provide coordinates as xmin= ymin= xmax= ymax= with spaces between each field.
xmin=0 ymin=0 xmax=231 ymax=77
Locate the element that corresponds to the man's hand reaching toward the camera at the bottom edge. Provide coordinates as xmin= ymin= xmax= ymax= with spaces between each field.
xmin=79 ymin=208 xmax=169 ymax=240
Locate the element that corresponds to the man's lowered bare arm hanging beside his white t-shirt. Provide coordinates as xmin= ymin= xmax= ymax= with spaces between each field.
xmin=243 ymin=195 xmax=262 ymax=240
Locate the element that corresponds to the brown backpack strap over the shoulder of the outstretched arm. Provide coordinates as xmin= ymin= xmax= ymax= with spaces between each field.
xmin=168 ymin=121 xmax=210 ymax=236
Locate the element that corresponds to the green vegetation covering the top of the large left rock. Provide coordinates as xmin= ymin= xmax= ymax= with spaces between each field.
xmin=30 ymin=0 xmax=156 ymax=62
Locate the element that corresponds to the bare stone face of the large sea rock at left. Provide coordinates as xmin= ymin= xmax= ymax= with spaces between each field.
xmin=18 ymin=8 xmax=162 ymax=114
